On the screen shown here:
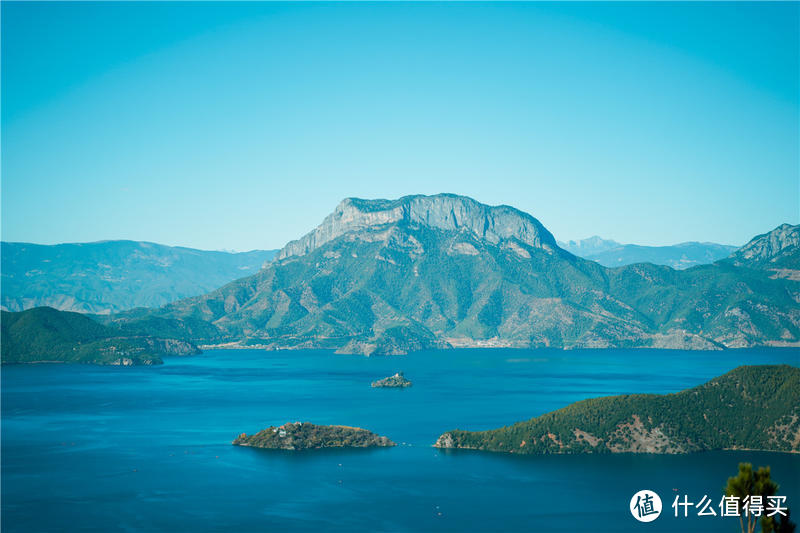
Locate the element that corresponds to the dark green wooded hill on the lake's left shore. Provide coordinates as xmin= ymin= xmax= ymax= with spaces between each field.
xmin=0 ymin=307 xmax=199 ymax=365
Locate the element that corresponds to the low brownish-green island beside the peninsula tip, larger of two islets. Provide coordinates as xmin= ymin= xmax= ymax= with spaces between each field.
xmin=233 ymin=422 xmax=396 ymax=450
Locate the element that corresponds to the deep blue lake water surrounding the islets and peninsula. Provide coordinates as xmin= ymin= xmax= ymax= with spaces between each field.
xmin=2 ymin=349 xmax=800 ymax=533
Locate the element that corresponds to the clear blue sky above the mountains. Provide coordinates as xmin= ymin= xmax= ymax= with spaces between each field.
xmin=2 ymin=1 xmax=800 ymax=250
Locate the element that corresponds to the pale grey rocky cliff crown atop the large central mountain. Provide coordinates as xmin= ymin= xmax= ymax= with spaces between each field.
xmin=277 ymin=194 xmax=557 ymax=260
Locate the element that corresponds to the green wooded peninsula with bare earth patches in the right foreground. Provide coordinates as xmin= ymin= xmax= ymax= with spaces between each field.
xmin=435 ymin=365 xmax=800 ymax=454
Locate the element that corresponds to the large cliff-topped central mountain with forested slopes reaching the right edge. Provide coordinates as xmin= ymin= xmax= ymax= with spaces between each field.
xmin=108 ymin=194 xmax=800 ymax=354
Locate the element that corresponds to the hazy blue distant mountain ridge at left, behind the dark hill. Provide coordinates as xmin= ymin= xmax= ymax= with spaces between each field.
xmin=1 ymin=241 xmax=275 ymax=314
